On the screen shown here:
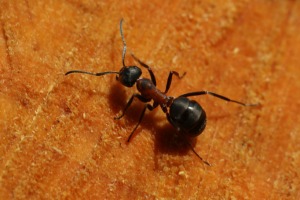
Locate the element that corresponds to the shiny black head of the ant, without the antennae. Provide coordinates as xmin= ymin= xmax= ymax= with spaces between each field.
xmin=116 ymin=66 xmax=142 ymax=87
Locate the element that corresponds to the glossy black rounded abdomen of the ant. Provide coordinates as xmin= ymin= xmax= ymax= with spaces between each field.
xmin=168 ymin=97 xmax=206 ymax=137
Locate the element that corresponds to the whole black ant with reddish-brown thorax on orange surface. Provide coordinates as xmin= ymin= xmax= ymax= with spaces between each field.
xmin=65 ymin=19 xmax=257 ymax=166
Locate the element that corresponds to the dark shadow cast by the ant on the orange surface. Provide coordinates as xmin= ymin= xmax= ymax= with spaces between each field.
xmin=108 ymin=82 xmax=201 ymax=165
